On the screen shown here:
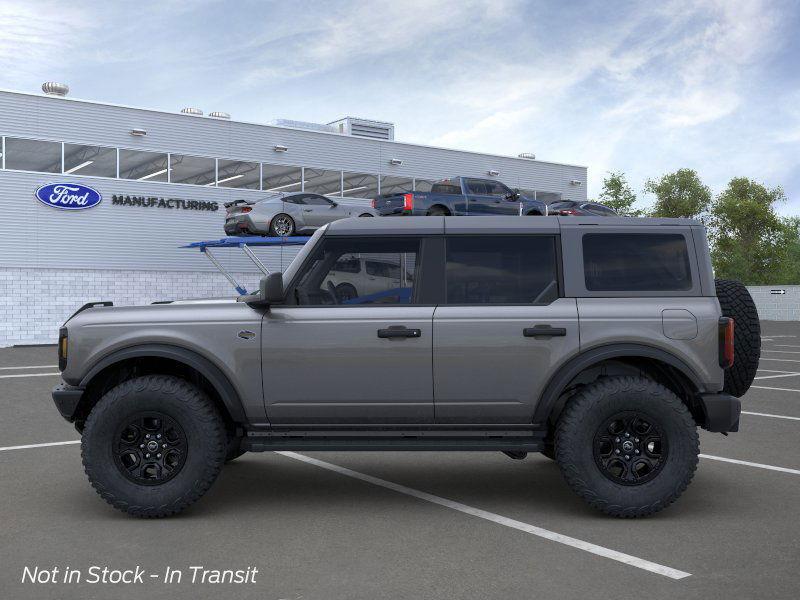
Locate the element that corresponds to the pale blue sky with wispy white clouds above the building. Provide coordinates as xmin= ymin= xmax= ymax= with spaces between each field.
xmin=0 ymin=0 xmax=800 ymax=215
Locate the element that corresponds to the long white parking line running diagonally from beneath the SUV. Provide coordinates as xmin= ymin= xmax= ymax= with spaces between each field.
xmin=278 ymin=451 xmax=691 ymax=579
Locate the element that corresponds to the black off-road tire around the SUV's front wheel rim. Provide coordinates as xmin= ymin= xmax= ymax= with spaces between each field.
xmin=81 ymin=375 xmax=227 ymax=517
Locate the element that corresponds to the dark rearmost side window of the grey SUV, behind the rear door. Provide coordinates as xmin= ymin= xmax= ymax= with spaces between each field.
xmin=583 ymin=233 xmax=692 ymax=292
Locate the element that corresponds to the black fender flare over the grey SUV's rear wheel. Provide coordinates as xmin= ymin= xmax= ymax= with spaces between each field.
xmin=533 ymin=344 xmax=703 ymax=423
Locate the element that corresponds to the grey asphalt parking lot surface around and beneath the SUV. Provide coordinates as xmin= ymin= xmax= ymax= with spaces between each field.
xmin=0 ymin=322 xmax=800 ymax=600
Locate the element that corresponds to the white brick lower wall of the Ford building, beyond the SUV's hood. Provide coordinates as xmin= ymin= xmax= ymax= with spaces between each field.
xmin=0 ymin=269 xmax=258 ymax=347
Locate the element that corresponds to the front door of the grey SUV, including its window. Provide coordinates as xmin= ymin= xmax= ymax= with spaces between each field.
xmin=262 ymin=236 xmax=434 ymax=425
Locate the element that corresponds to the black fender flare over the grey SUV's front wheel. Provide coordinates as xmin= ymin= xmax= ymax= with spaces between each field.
xmin=80 ymin=344 xmax=247 ymax=423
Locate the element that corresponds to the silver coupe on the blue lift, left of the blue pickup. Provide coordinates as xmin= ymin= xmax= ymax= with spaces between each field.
xmin=225 ymin=192 xmax=378 ymax=237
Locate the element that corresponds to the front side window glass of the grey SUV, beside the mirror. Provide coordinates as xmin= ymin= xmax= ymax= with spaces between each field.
xmin=290 ymin=237 xmax=420 ymax=306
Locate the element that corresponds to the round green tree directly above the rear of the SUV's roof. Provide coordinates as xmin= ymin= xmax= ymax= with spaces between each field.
xmin=644 ymin=169 xmax=711 ymax=219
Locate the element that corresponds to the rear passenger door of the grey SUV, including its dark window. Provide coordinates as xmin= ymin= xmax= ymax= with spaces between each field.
xmin=433 ymin=230 xmax=579 ymax=424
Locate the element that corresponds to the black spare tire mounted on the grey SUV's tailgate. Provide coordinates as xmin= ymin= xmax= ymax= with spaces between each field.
xmin=714 ymin=279 xmax=761 ymax=397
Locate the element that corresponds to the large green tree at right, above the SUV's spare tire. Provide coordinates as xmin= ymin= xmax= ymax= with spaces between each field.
xmin=711 ymin=177 xmax=798 ymax=285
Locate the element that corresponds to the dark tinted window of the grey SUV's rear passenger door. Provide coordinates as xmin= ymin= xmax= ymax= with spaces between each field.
xmin=446 ymin=236 xmax=558 ymax=304
